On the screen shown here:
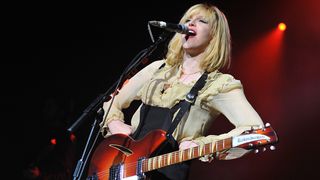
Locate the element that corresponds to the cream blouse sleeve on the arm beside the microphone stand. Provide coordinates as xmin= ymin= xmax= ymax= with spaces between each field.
xmin=100 ymin=60 xmax=164 ymax=136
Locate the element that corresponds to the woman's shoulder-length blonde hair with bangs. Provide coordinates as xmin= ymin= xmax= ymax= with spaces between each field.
xmin=166 ymin=3 xmax=231 ymax=72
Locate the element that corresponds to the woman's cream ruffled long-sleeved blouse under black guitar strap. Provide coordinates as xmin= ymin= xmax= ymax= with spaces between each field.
xmin=100 ymin=60 xmax=263 ymax=160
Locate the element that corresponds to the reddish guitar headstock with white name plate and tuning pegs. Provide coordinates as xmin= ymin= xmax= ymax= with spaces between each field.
xmin=232 ymin=123 xmax=278 ymax=153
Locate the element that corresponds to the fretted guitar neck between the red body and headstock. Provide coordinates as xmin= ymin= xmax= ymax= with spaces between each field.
xmin=142 ymin=138 xmax=232 ymax=172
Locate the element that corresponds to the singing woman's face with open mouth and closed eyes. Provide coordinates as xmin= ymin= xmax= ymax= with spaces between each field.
xmin=182 ymin=13 xmax=211 ymax=56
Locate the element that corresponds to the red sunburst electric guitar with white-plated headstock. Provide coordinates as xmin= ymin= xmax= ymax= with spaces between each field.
xmin=88 ymin=123 xmax=278 ymax=180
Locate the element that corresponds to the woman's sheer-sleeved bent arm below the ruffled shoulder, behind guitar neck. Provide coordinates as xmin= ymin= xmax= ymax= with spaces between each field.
xmin=194 ymin=88 xmax=263 ymax=161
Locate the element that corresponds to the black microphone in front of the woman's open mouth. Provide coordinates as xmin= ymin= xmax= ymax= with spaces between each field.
xmin=149 ymin=21 xmax=195 ymax=35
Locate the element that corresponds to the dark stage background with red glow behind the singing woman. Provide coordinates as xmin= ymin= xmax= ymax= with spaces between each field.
xmin=0 ymin=0 xmax=320 ymax=180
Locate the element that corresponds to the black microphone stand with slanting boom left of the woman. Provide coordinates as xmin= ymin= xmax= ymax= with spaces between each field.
xmin=68 ymin=32 xmax=170 ymax=180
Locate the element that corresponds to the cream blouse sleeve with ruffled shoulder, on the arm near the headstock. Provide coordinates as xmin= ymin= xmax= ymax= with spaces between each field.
xmin=193 ymin=76 xmax=263 ymax=161
